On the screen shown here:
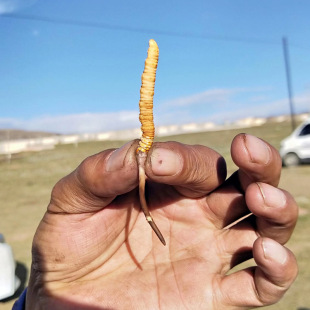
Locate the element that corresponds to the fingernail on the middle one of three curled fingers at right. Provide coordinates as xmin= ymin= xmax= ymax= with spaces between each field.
xmin=256 ymin=183 xmax=286 ymax=208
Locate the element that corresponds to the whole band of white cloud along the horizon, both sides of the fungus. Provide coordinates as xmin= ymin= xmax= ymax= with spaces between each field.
xmin=0 ymin=89 xmax=310 ymax=133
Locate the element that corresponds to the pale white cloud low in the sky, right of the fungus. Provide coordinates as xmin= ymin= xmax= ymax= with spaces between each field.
xmin=158 ymin=88 xmax=310 ymax=124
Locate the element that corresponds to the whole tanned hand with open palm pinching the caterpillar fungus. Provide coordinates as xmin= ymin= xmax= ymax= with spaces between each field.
xmin=27 ymin=134 xmax=298 ymax=310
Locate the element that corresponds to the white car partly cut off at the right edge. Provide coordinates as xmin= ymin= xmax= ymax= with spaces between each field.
xmin=280 ymin=119 xmax=310 ymax=167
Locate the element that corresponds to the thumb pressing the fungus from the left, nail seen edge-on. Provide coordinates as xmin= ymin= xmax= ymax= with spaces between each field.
xmin=48 ymin=141 xmax=138 ymax=213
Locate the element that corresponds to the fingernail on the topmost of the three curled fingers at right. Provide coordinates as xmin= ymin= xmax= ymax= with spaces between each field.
xmin=245 ymin=135 xmax=271 ymax=164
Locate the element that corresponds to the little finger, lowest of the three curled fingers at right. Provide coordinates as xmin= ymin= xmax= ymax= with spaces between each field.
xmin=221 ymin=238 xmax=298 ymax=307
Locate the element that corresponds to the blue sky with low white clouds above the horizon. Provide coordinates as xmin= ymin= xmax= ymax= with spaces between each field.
xmin=0 ymin=0 xmax=310 ymax=133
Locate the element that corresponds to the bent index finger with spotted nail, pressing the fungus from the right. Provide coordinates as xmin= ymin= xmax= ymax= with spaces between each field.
xmin=146 ymin=142 xmax=226 ymax=198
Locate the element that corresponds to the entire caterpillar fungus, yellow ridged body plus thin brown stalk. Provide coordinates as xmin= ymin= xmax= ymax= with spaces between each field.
xmin=137 ymin=39 xmax=166 ymax=245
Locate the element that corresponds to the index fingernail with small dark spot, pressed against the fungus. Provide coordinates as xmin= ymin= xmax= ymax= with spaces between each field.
xmin=151 ymin=148 xmax=183 ymax=176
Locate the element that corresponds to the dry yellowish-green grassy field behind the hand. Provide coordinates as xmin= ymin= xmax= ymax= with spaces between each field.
xmin=0 ymin=123 xmax=310 ymax=310
